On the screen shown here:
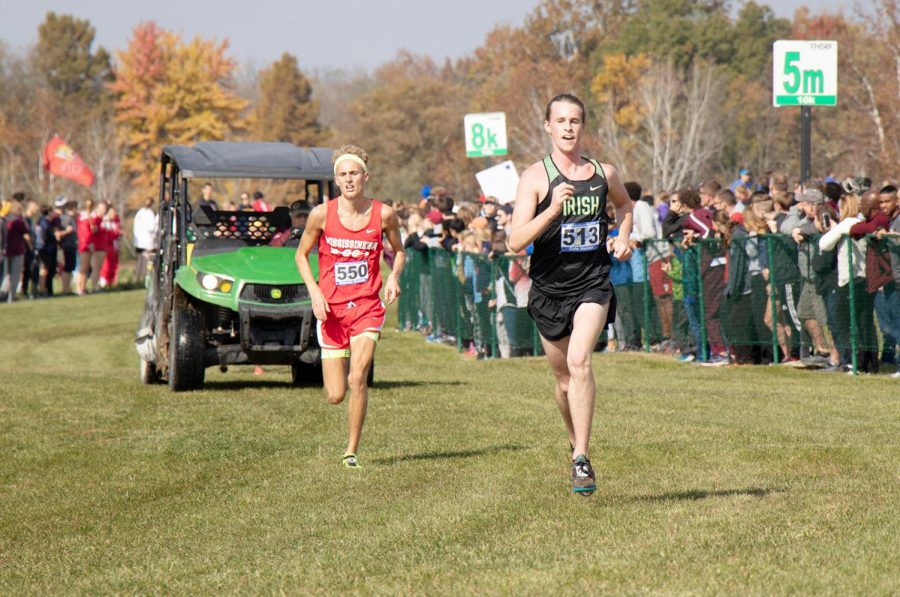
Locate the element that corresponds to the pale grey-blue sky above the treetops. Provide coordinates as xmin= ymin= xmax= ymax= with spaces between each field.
xmin=0 ymin=0 xmax=852 ymax=71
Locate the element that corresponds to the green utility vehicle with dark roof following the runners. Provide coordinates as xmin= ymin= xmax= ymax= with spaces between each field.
xmin=135 ymin=142 xmax=348 ymax=392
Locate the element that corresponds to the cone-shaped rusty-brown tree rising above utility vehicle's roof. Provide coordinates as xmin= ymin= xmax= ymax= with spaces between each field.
xmin=252 ymin=52 xmax=328 ymax=147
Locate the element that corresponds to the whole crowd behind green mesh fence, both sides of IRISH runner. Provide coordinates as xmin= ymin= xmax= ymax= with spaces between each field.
xmin=397 ymin=170 xmax=900 ymax=377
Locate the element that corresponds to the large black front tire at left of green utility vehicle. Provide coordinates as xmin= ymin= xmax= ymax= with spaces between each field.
xmin=169 ymin=309 xmax=206 ymax=392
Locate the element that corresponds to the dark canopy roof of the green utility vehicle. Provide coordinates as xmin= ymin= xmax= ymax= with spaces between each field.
xmin=163 ymin=141 xmax=334 ymax=180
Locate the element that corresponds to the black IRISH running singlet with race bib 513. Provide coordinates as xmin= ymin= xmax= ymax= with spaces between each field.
xmin=529 ymin=156 xmax=611 ymax=297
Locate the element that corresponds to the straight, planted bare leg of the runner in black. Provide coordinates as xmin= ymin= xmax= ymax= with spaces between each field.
xmin=566 ymin=303 xmax=609 ymax=458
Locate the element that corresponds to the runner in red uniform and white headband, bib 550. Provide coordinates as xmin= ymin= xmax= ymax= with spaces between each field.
xmin=296 ymin=145 xmax=406 ymax=468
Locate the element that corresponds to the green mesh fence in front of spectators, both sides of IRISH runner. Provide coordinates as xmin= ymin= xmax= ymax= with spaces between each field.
xmin=399 ymin=234 xmax=900 ymax=371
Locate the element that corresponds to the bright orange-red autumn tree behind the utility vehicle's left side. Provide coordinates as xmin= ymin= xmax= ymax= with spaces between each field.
xmin=112 ymin=22 xmax=247 ymax=201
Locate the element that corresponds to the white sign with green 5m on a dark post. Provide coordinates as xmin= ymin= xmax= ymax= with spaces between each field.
xmin=772 ymin=39 xmax=837 ymax=106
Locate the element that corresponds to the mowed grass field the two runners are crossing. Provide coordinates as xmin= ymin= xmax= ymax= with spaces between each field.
xmin=0 ymin=292 xmax=900 ymax=595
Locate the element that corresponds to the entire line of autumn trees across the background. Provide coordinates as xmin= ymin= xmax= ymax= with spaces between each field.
xmin=0 ymin=0 xmax=900 ymax=208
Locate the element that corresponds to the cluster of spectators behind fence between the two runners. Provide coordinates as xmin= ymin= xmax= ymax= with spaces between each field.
xmin=397 ymin=187 xmax=533 ymax=358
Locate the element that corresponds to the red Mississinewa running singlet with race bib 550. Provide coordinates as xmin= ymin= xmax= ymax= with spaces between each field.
xmin=319 ymin=199 xmax=383 ymax=304
